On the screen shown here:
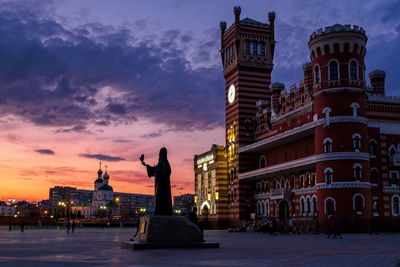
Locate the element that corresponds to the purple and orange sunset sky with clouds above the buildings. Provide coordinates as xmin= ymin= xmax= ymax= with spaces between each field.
xmin=0 ymin=0 xmax=400 ymax=201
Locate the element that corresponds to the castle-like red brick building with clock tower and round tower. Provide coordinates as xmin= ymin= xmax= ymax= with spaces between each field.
xmin=196 ymin=7 xmax=400 ymax=231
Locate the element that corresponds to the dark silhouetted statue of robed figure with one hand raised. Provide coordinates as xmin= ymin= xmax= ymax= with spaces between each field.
xmin=139 ymin=147 xmax=172 ymax=215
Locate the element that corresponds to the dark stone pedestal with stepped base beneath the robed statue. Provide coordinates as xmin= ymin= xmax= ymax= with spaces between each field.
xmin=122 ymin=215 xmax=219 ymax=250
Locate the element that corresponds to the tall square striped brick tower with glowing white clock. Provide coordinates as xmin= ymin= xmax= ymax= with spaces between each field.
xmin=220 ymin=6 xmax=275 ymax=226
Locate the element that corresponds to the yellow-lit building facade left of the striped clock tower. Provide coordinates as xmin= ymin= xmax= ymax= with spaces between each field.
xmin=194 ymin=145 xmax=229 ymax=228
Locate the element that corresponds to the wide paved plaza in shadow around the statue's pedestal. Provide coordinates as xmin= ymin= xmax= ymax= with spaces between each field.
xmin=0 ymin=228 xmax=400 ymax=267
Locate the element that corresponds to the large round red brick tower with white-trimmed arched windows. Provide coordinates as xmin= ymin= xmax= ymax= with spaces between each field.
xmin=308 ymin=24 xmax=371 ymax=230
